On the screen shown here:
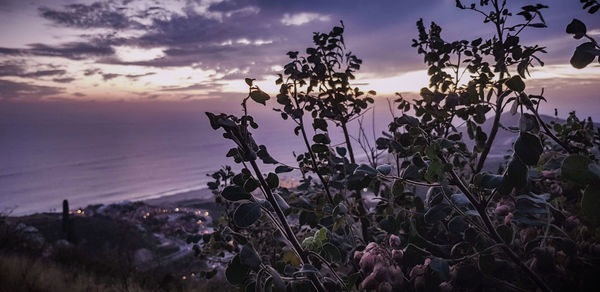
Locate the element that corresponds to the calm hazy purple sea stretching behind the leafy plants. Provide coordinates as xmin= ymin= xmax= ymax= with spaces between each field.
xmin=0 ymin=100 xmax=389 ymax=215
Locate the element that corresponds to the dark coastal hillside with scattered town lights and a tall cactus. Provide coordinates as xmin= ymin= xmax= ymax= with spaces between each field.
xmin=0 ymin=202 xmax=234 ymax=292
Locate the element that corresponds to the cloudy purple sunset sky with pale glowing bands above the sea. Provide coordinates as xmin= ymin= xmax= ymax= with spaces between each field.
xmin=0 ymin=0 xmax=600 ymax=105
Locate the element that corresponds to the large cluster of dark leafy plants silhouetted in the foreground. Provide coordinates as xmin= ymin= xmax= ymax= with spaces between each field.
xmin=197 ymin=0 xmax=600 ymax=291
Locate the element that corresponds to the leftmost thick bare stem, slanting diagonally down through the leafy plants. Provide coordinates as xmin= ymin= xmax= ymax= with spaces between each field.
xmin=246 ymin=157 xmax=327 ymax=292
